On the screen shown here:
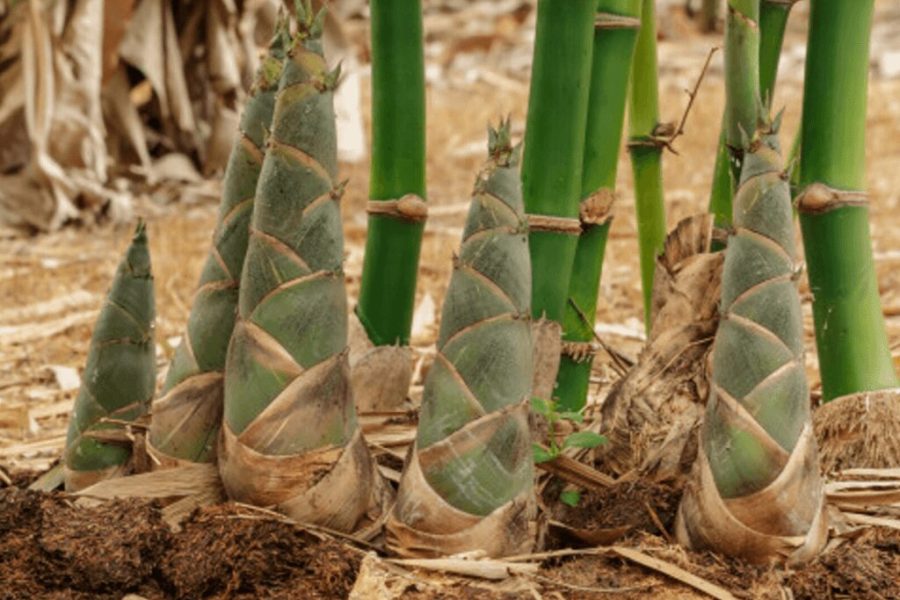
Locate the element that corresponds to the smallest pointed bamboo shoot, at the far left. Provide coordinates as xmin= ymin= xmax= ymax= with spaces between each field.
xmin=63 ymin=222 xmax=156 ymax=491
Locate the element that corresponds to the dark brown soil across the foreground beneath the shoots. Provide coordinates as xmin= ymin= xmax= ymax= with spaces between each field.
xmin=0 ymin=482 xmax=900 ymax=600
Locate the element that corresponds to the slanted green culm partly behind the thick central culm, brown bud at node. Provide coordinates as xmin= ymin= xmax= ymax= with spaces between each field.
xmin=556 ymin=0 xmax=641 ymax=410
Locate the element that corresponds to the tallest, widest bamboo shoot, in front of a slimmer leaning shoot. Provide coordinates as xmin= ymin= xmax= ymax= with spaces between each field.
xmin=218 ymin=3 xmax=381 ymax=531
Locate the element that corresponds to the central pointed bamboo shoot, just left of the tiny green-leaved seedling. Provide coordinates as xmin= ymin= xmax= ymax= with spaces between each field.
xmin=387 ymin=121 xmax=535 ymax=556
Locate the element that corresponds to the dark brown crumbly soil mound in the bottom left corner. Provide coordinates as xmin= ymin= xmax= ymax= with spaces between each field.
xmin=0 ymin=488 xmax=360 ymax=600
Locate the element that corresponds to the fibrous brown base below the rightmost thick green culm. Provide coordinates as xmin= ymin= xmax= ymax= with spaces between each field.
xmin=813 ymin=389 xmax=900 ymax=473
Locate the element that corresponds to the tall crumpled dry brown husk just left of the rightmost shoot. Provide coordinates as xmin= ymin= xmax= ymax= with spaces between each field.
xmin=596 ymin=214 xmax=724 ymax=480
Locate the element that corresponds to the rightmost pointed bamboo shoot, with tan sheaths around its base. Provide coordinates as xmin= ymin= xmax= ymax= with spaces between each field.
xmin=676 ymin=119 xmax=827 ymax=562
